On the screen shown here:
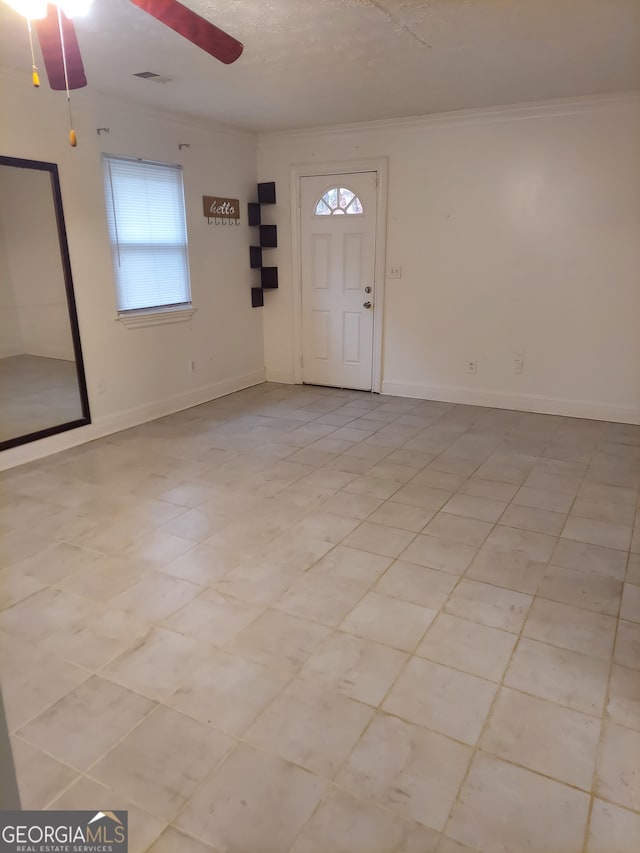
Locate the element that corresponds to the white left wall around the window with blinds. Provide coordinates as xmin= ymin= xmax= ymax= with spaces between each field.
xmin=0 ymin=71 xmax=264 ymax=467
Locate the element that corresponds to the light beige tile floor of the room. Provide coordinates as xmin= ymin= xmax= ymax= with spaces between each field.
xmin=0 ymin=384 xmax=640 ymax=853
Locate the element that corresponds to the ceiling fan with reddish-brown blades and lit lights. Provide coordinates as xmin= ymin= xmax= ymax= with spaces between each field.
xmin=5 ymin=0 xmax=243 ymax=91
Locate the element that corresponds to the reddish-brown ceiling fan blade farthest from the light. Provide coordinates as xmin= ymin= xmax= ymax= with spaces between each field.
xmin=131 ymin=0 xmax=244 ymax=65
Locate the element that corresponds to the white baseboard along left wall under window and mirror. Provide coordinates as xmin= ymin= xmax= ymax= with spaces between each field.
xmin=0 ymin=369 xmax=265 ymax=471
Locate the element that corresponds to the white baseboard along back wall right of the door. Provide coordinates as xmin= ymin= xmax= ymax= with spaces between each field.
xmin=382 ymin=380 xmax=640 ymax=424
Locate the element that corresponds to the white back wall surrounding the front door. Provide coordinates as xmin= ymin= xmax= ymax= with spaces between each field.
xmin=258 ymin=96 xmax=640 ymax=422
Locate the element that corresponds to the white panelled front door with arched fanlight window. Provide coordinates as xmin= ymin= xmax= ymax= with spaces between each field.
xmin=300 ymin=172 xmax=377 ymax=391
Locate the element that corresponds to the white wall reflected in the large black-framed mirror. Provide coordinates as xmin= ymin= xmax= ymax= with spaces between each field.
xmin=0 ymin=166 xmax=74 ymax=361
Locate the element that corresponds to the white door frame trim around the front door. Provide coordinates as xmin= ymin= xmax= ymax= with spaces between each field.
xmin=290 ymin=157 xmax=389 ymax=394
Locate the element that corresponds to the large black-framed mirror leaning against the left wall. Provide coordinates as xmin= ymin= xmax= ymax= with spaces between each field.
xmin=0 ymin=156 xmax=90 ymax=450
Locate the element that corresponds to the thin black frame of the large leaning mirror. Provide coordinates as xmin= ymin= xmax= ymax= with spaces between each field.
xmin=0 ymin=154 xmax=91 ymax=451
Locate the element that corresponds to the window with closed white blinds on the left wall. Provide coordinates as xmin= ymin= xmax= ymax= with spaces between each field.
xmin=103 ymin=155 xmax=191 ymax=314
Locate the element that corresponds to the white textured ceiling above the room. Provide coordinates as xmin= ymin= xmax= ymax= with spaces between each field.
xmin=0 ymin=0 xmax=640 ymax=131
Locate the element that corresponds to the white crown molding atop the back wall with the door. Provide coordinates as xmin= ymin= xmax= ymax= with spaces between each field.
xmin=258 ymin=90 xmax=640 ymax=148
